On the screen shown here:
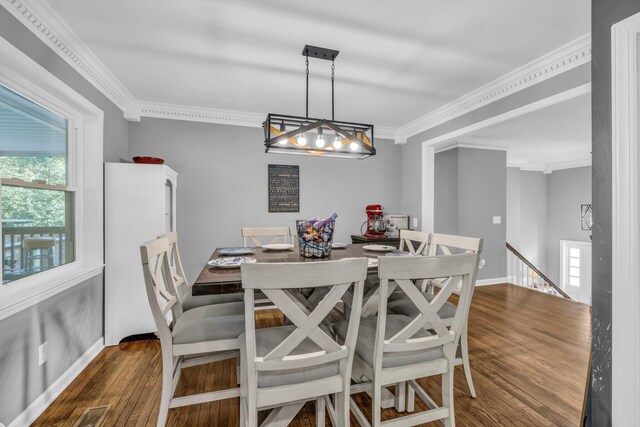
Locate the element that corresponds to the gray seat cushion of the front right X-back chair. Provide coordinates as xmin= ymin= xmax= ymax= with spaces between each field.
xmin=333 ymin=314 xmax=444 ymax=368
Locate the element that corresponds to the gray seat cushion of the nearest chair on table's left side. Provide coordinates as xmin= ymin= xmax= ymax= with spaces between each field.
xmin=171 ymin=303 xmax=244 ymax=344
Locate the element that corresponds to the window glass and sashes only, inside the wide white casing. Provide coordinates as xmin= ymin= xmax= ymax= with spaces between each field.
xmin=0 ymin=85 xmax=75 ymax=284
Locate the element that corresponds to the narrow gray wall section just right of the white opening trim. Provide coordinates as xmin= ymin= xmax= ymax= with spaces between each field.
xmin=432 ymin=149 xmax=458 ymax=234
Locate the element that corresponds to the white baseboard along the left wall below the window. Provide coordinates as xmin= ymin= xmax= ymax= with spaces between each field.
xmin=8 ymin=337 xmax=104 ymax=427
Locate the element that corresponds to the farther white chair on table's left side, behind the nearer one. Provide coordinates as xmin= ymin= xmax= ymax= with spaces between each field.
xmin=158 ymin=231 xmax=244 ymax=314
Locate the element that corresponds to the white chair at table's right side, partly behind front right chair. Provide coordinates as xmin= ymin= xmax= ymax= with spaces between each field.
xmin=388 ymin=233 xmax=483 ymax=398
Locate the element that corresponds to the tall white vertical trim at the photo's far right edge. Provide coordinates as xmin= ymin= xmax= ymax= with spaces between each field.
xmin=608 ymin=13 xmax=640 ymax=426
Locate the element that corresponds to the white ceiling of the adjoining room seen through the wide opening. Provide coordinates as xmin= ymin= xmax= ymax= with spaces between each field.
xmin=471 ymin=94 xmax=591 ymax=170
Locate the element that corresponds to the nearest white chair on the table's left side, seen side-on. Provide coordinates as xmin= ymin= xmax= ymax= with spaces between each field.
xmin=140 ymin=238 xmax=245 ymax=427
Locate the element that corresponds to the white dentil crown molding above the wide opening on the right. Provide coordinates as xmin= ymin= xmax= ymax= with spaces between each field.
xmin=397 ymin=33 xmax=591 ymax=143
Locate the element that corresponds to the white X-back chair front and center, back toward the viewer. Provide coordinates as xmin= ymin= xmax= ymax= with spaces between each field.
xmin=239 ymin=258 xmax=367 ymax=427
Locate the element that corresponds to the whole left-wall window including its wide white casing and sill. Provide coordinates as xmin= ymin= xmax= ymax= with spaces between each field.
xmin=0 ymin=37 xmax=104 ymax=320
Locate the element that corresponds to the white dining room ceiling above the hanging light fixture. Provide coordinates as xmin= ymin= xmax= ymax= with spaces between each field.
xmin=49 ymin=0 xmax=590 ymax=127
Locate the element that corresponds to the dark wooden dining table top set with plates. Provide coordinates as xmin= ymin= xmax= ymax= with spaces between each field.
xmin=194 ymin=244 xmax=384 ymax=295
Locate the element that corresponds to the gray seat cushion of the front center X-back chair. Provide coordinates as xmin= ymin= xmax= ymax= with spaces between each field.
xmin=238 ymin=325 xmax=340 ymax=387
